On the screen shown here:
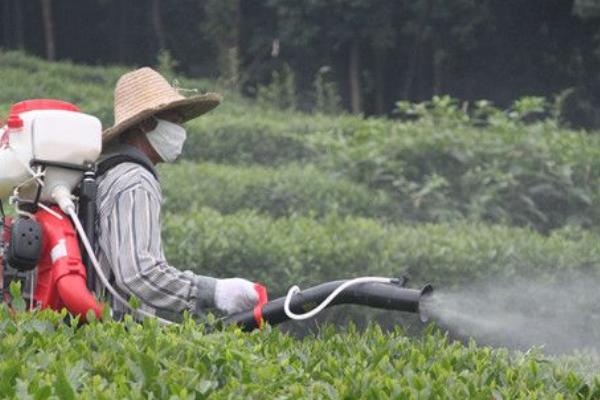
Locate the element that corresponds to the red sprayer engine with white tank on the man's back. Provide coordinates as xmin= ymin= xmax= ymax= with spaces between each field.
xmin=0 ymin=99 xmax=102 ymax=317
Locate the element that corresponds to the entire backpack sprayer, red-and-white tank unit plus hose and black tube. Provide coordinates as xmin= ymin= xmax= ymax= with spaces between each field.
xmin=0 ymin=100 xmax=433 ymax=330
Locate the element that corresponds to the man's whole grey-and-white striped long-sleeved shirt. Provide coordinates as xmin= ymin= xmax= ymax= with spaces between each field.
xmin=96 ymin=146 xmax=216 ymax=314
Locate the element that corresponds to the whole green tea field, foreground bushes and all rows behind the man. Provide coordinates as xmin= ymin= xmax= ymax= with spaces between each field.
xmin=0 ymin=52 xmax=600 ymax=399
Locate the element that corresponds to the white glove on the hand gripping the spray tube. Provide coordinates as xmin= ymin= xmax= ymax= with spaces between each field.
xmin=215 ymin=278 xmax=258 ymax=314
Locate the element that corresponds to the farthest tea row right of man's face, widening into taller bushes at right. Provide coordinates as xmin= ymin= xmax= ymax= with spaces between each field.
xmin=186 ymin=114 xmax=600 ymax=231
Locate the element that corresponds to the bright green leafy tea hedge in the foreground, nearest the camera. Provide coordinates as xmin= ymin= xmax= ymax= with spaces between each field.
xmin=0 ymin=307 xmax=600 ymax=399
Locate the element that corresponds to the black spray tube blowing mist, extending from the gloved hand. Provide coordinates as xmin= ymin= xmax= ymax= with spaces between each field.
xmin=224 ymin=281 xmax=433 ymax=331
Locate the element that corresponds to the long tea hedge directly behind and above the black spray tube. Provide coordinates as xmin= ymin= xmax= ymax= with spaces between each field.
xmin=163 ymin=209 xmax=600 ymax=294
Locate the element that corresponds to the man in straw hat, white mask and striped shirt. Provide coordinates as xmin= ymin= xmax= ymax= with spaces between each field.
xmin=96 ymin=68 xmax=258 ymax=314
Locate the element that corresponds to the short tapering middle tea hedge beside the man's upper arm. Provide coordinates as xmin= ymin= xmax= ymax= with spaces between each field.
xmin=160 ymin=162 xmax=395 ymax=218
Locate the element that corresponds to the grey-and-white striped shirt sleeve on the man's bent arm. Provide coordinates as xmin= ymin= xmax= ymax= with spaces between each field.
xmin=110 ymin=186 xmax=216 ymax=313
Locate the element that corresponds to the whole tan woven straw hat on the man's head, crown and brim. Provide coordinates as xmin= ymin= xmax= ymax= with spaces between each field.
xmin=102 ymin=67 xmax=221 ymax=143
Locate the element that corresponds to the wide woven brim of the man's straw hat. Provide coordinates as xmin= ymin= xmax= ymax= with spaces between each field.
xmin=102 ymin=93 xmax=221 ymax=143
